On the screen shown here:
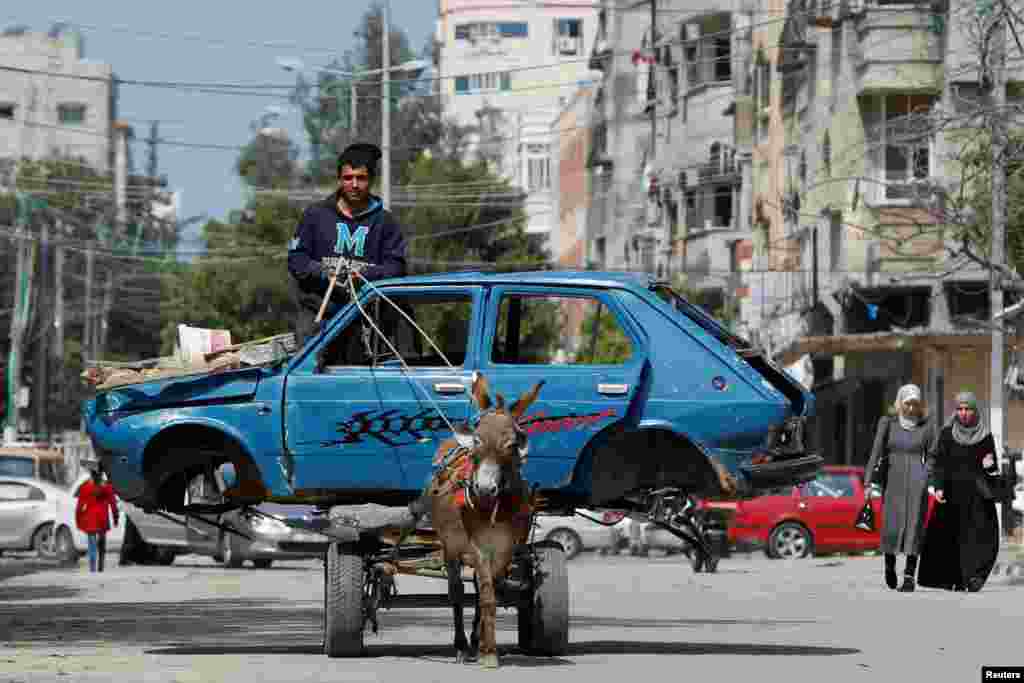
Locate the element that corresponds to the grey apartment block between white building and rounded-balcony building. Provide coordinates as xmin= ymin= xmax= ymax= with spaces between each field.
xmin=588 ymin=0 xmax=753 ymax=332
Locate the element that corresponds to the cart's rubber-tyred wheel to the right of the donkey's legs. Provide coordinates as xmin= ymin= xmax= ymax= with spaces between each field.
xmin=518 ymin=546 xmax=569 ymax=656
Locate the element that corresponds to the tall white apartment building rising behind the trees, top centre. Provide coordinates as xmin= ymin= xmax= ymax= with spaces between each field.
xmin=436 ymin=0 xmax=597 ymax=240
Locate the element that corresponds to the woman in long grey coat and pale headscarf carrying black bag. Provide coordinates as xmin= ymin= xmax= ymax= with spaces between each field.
xmin=865 ymin=384 xmax=935 ymax=593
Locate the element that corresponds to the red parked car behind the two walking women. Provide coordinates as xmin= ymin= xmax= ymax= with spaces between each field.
xmin=729 ymin=465 xmax=882 ymax=558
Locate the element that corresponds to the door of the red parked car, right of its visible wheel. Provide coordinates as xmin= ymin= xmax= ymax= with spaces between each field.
xmin=797 ymin=472 xmax=863 ymax=548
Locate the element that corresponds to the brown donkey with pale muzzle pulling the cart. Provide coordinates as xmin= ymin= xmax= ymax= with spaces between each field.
xmin=428 ymin=374 xmax=544 ymax=668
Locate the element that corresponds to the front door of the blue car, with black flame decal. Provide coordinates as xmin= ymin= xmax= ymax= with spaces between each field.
xmin=285 ymin=287 xmax=482 ymax=492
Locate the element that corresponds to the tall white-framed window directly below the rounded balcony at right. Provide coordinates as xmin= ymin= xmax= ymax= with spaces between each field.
xmin=878 ymin=95 xmax=934 ymax=200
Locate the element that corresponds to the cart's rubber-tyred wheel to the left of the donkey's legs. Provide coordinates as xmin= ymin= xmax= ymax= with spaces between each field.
xmin=324 ymin=543 xmax=364 ymax=657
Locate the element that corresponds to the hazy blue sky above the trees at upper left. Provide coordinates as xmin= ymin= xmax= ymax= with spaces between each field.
xmin=0 ymin=0 xmax=437 ymax=251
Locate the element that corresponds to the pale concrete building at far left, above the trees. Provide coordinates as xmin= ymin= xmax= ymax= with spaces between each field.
xmin=0 ymin=25 xmax=117 ymax=184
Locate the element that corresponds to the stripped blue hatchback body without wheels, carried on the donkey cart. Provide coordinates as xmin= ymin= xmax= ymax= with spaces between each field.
xmin=83 ymin=271 xmax=814 ymax=507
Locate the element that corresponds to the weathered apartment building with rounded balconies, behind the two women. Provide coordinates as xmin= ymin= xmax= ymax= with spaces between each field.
xmin=736 ymin=0 xmax=1024 ymax=464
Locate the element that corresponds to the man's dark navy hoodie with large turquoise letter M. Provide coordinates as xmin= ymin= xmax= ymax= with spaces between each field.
xmin=288 ymin=193 xmax=406 ymax=316
